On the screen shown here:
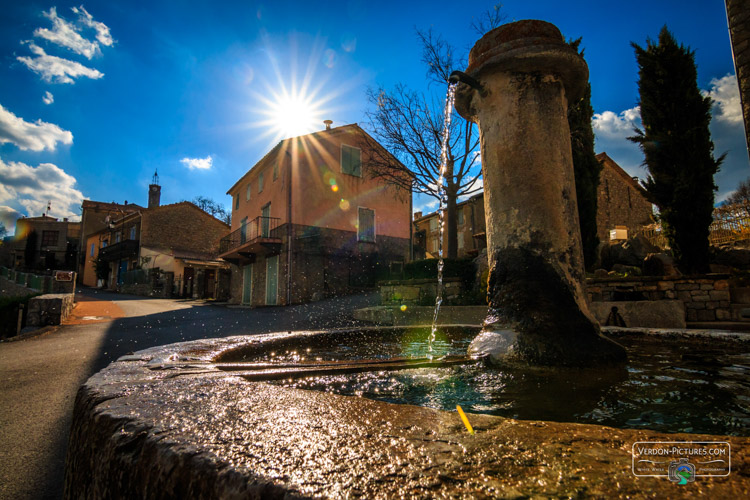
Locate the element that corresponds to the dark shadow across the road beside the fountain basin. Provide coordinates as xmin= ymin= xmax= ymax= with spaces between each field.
xmin=25 ymin=289 xmax=378 ymax=498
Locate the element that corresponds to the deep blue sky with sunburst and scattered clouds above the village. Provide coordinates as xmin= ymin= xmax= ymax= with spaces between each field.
xmin=0 ymin=0 xmax=750 ymax=228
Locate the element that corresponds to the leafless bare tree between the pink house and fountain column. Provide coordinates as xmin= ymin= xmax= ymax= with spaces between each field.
xmin=365 ymin=30 xmax=481 ymax=258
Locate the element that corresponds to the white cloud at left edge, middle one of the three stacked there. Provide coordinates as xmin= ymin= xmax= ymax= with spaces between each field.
xmin=0 ymin=104 xmax=73 ymax=151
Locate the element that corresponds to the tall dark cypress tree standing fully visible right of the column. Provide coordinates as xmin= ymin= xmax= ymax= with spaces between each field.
xmin=629 ymin=26 xmax=724 ymax=274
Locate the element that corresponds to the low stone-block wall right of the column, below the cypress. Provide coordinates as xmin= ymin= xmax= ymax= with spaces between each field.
xmin=586 ymin=274 xmax=732 ymax=322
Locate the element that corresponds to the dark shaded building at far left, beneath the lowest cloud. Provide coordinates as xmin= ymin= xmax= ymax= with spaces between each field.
xmin=10 ymin=215 xmax=81 ymax=270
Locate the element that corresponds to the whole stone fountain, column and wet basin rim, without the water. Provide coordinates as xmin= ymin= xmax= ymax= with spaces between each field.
xmin=64 ymin=21 xmax=750 ymax=498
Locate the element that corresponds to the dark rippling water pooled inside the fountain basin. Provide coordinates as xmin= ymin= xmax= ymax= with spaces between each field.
xmin=217 ymin=327 xmax=750 ymax=435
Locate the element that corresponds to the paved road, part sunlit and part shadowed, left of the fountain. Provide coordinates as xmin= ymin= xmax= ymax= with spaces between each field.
xmin=0 ymin=289 xmax=377 ymax=499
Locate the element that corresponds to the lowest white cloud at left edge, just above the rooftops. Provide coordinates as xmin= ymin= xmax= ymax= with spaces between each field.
xmin=0 ymin=159 xmax=83 ymax=218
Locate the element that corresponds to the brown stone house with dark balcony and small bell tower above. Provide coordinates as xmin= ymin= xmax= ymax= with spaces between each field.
xmin=83 ymin=176 xmax=229 ymax=298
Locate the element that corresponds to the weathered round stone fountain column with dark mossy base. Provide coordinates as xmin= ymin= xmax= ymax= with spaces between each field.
xmin=456 ymin=20 xmax=625 ymax=366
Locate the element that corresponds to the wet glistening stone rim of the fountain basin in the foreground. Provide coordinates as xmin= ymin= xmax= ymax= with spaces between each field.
xmin=64 ymin=330 xmax=750 ymax=498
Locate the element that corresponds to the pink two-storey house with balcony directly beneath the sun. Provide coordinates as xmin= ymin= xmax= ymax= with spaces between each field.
xmin=220 ymin=121 xmax=411 ymax=306
